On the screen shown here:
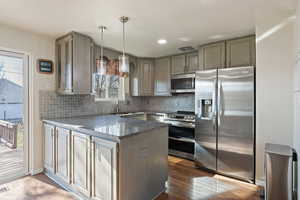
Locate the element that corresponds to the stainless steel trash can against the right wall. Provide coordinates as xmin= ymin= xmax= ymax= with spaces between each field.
xmin=265 ymin=143 xmax=297 ymax=200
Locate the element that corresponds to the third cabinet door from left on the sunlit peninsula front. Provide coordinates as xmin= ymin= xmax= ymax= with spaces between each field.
xmin=71 ymin=131 xmax=91 ymax=197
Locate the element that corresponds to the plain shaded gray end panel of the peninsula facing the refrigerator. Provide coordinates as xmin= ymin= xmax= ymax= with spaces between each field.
xmin=119 ymin=127 xmax=168 ymax=200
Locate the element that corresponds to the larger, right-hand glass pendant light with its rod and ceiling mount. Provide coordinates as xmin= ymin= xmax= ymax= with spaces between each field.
xmin=119 ymin=16 xmax=129 ymax=77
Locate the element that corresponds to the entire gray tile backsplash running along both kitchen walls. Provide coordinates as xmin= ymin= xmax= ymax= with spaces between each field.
xmin=39 ymin=91 xmax=195 ymax=119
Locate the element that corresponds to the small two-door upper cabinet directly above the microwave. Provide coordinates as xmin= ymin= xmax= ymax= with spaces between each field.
xmin=172 ymin=52 xmax=199 ymax=74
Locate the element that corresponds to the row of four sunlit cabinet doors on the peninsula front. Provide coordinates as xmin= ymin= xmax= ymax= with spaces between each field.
xmin=44 ymin=124 xmax=118 ymax=200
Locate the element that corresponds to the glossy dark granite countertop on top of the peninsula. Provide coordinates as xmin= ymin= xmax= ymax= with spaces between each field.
xmin=43 ymin=115 xmax=168 ymax=142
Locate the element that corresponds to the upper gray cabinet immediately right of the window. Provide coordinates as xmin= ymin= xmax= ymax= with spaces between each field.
xmin=130 ymin=58 xmax=154 ymax=96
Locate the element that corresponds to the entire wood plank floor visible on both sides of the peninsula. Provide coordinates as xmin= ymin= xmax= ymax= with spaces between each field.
xmin=0 ymin=156 xmax=260 ymax=200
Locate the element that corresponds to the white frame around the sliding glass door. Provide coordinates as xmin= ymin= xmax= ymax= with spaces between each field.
xmin=0 ymin=47 xmax=33 ymax=182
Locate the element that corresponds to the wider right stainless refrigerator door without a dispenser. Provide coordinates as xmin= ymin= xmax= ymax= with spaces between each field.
xmin=217 ymin=67 xmax=255 ymax=182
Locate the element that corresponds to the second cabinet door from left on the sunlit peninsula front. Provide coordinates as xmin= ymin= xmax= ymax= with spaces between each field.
xmin=56 ymin=127 xmax=71 ymax=183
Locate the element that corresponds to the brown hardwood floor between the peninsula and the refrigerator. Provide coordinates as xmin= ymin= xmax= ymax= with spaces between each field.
xmin=157 ymin=156 xmax=260 ymax=200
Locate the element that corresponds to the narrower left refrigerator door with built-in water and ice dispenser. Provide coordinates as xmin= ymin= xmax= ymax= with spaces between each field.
xmin=195 ymin=70 xmax=217 ymax=170
